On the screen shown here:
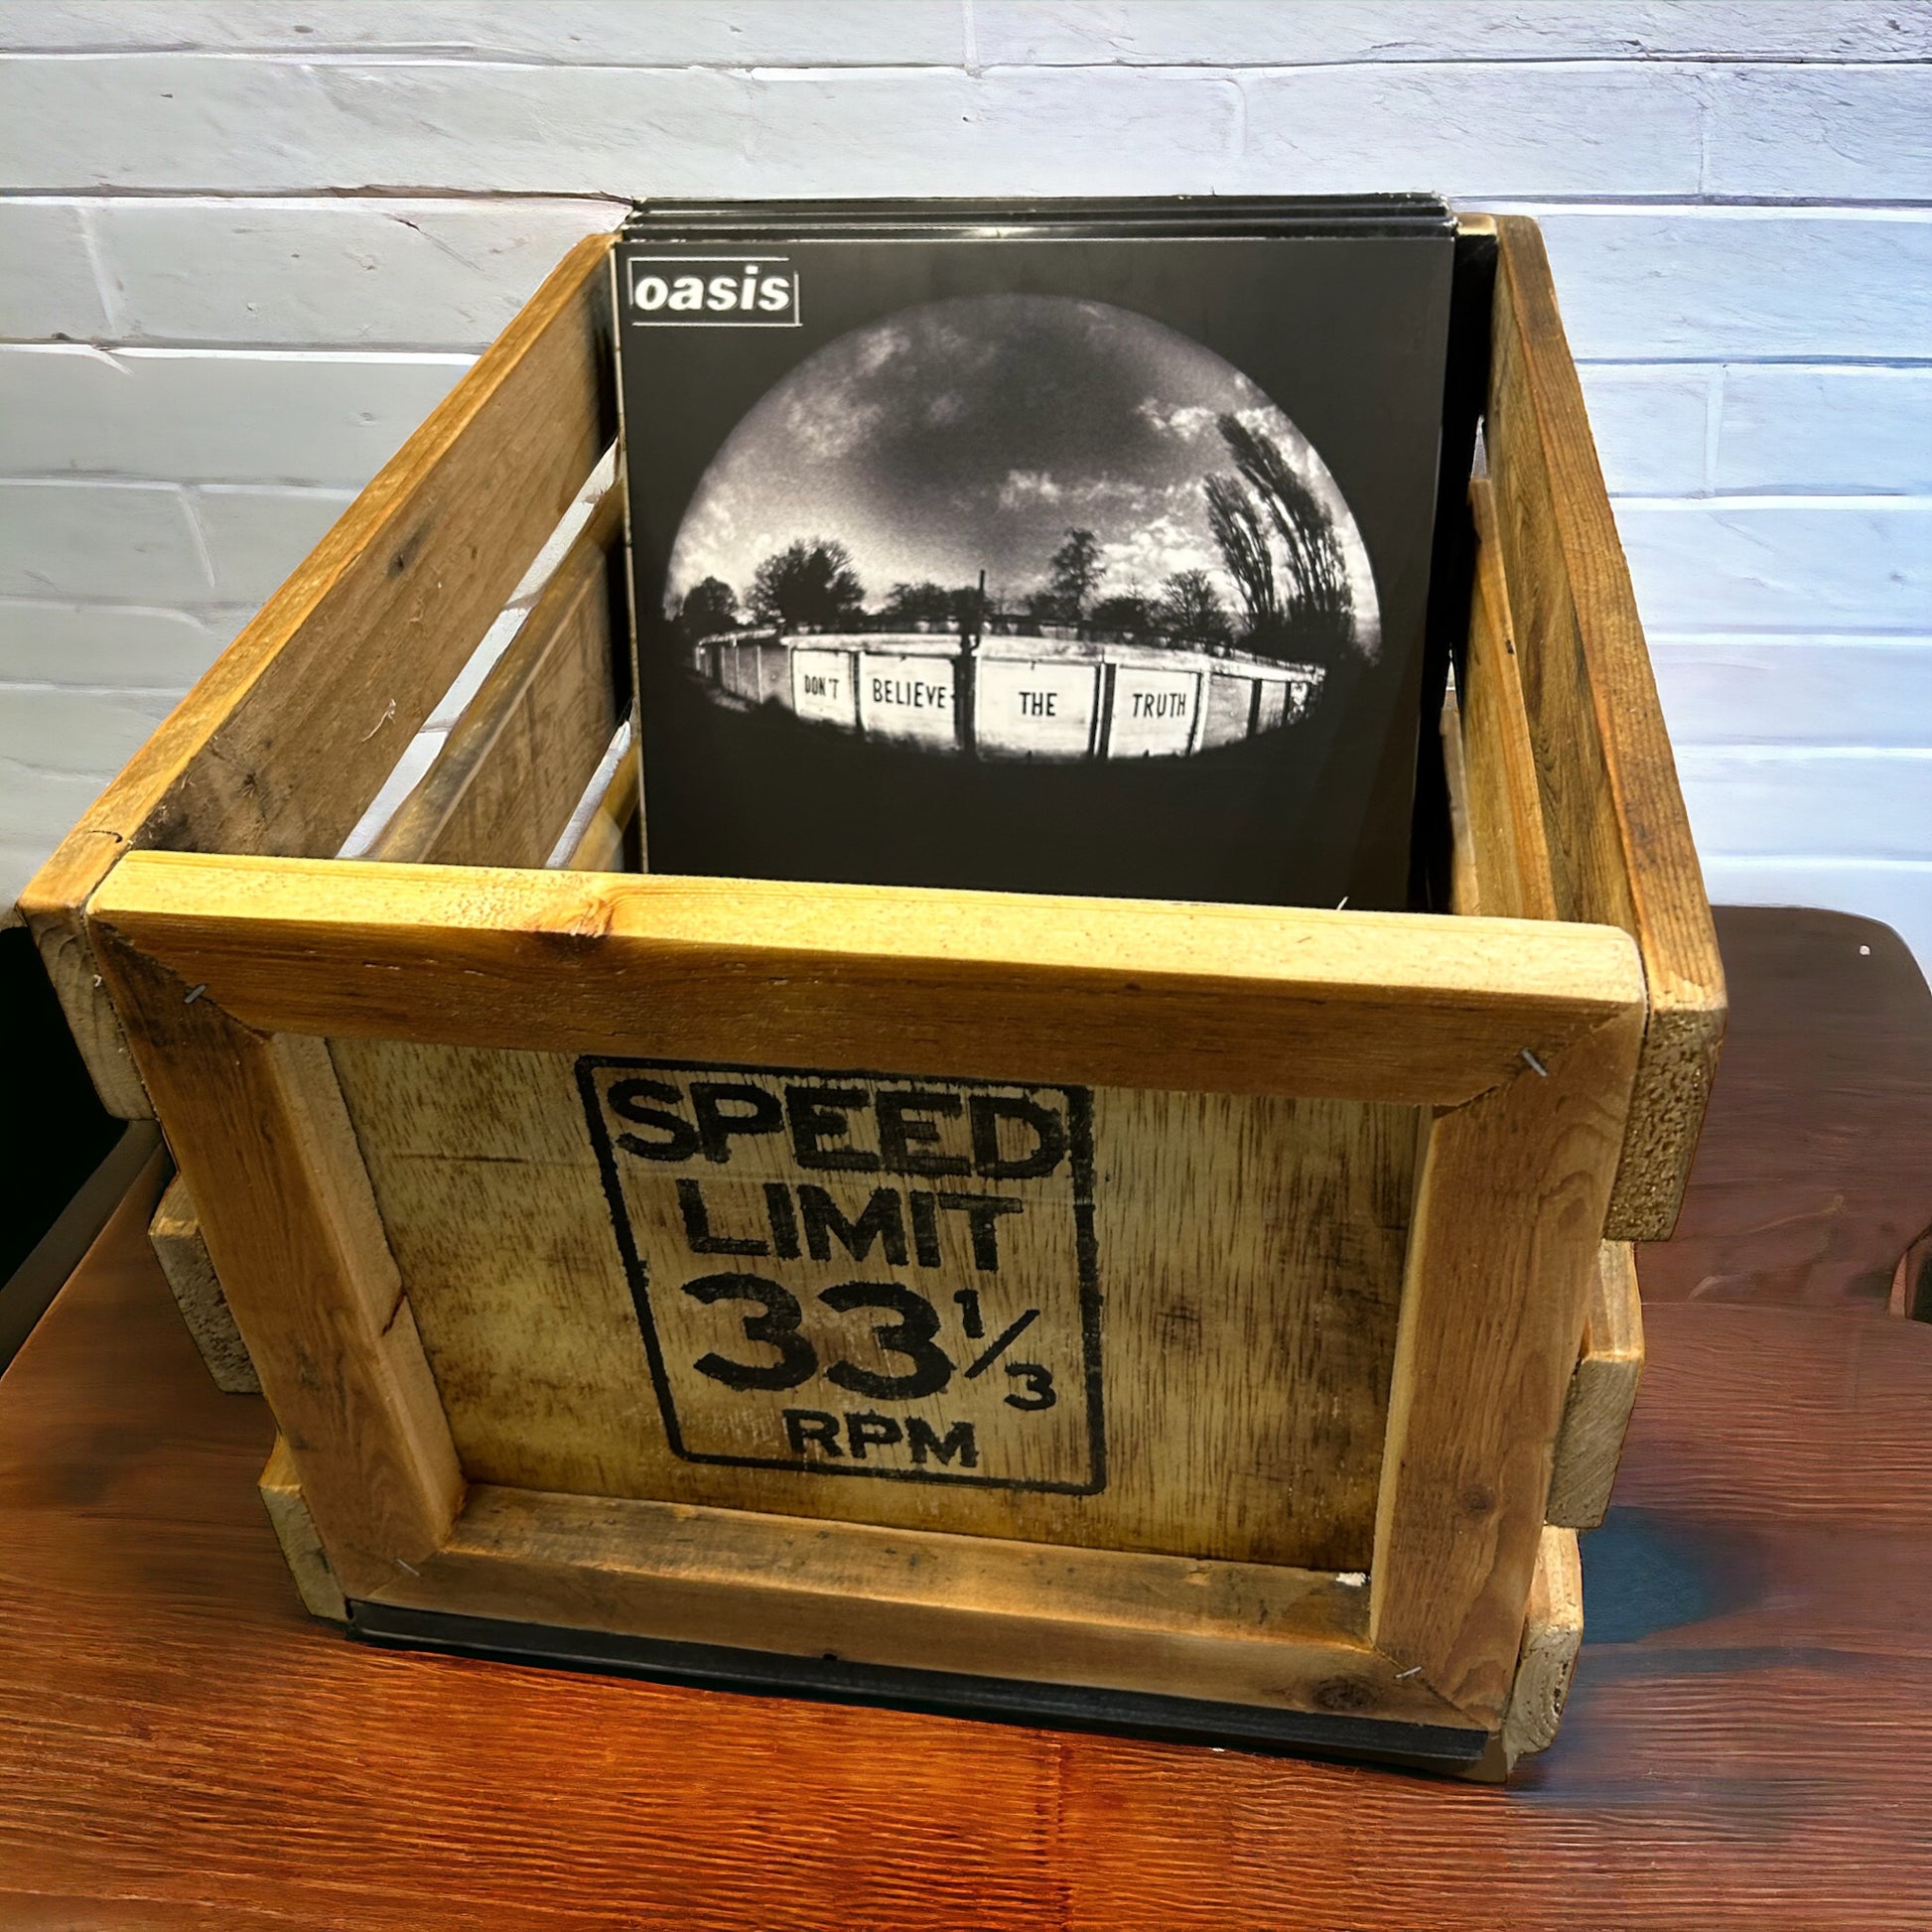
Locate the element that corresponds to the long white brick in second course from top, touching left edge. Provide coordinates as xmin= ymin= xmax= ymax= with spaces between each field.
xmin=0 ymin=54 xmax=1240 ymax=196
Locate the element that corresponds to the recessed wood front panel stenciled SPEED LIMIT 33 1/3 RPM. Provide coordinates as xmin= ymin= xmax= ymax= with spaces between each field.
xmin=333 ymin=1039 xmax=1418 ymax=1571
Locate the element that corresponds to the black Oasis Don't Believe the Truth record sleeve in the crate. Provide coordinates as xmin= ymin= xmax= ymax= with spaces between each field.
xmin=613 ymin=214 xmax=1452 ymax=908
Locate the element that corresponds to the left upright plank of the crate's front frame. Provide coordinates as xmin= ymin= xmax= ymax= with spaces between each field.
xmin=100 ymin=927 xmax=464 ymax=1588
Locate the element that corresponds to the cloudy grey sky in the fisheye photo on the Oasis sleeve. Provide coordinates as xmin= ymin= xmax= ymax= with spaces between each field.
xmin=666 ymin=282 xmax=1379 ymax=655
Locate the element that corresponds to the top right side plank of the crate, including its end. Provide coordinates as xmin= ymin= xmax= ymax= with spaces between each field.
xmin=1485 ymin=214 xmax=1725 ymax=1240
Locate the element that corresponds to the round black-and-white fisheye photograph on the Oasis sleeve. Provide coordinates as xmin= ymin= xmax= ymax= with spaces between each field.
xmin=664 ymin=294 xmax=1381 ymax=761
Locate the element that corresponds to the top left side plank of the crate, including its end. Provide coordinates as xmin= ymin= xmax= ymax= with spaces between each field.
xmin=21 ymin=235 xmax=615 ymax=1119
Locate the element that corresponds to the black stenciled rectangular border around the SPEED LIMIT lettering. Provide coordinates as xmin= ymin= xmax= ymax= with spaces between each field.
xmin=576 ymin=1053 xmax=1107 ymax=1495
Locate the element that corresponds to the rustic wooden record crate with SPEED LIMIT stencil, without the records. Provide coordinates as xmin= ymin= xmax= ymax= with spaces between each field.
xmin=21 ymin=218 xmax=1724 ymax=1773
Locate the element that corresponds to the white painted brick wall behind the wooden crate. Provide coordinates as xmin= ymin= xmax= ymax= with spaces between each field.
xmin=0 ymin=0 xmax=1932 ymax=964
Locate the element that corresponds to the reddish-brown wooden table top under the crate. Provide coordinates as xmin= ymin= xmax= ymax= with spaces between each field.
xmin=0 ymin=913 xmax=1932 ymax=1932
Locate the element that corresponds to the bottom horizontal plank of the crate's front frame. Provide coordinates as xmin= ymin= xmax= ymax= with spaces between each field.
xmin=368 ymin=1485 xmax=1466 ymax=1725
